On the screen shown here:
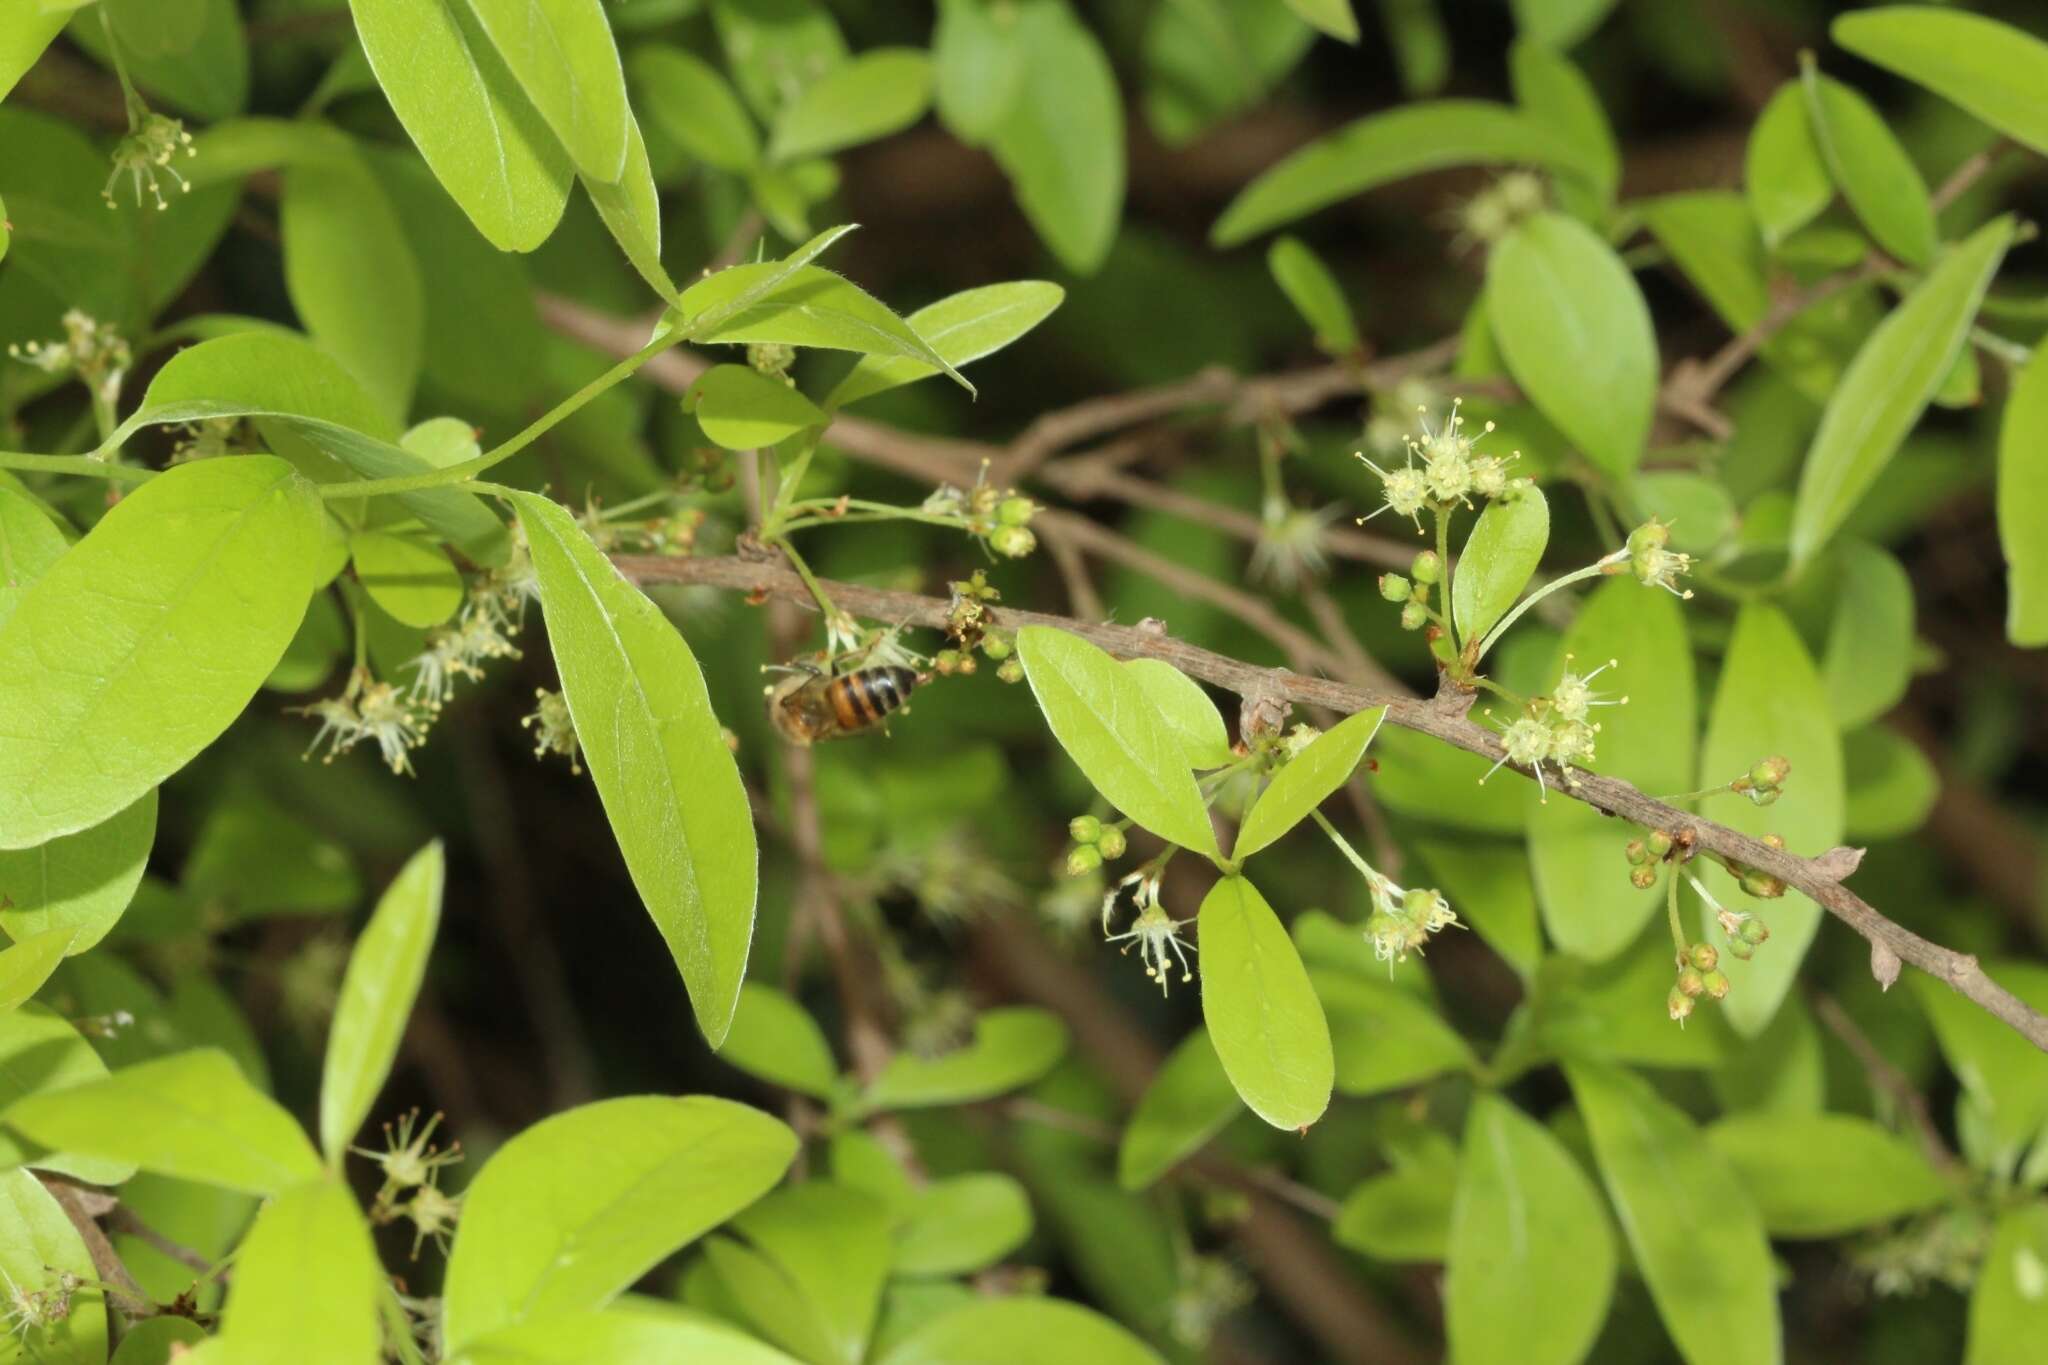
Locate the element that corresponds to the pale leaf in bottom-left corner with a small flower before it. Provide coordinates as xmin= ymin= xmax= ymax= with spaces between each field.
xmin=0 ymin=1171 xmax=106 ymax=1365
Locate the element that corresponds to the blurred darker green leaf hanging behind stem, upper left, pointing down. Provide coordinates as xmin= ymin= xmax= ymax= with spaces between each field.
xmin=279 ymin=139 xmax=426 ymax=420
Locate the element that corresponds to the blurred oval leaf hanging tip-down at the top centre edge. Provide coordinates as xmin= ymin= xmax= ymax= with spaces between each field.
xmin=989 ymin=4 xmax=1124 ymax=274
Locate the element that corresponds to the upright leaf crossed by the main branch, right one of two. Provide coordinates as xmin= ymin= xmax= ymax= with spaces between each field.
xmin=1698 ymin=602 xmax=1843 ymax=1038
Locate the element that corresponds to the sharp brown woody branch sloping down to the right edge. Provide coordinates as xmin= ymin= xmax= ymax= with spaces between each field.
xmin=614 ymin=557 xmax=2048 ymax=1052
